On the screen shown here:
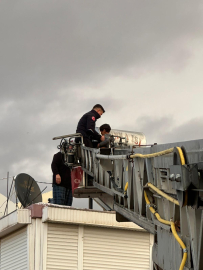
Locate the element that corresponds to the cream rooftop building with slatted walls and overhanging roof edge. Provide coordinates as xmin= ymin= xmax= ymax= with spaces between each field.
xmin=0 ymin=203 xmax=153 ymax=270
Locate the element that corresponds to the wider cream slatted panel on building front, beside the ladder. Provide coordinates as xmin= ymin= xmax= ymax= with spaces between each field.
xmin=83 ymin=227 xmax=150 ymax=270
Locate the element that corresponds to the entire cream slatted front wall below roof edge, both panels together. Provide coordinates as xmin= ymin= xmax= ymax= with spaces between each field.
xmin=46 ymin=223 xmax=150 ymax=270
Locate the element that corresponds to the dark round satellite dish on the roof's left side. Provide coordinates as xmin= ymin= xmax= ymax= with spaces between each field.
xmin=15 ymin=173 xmax=42 ymax=207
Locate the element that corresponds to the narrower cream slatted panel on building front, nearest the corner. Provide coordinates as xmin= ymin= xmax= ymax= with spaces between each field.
xmin=46 ymin=223 xmax=78 ymax=270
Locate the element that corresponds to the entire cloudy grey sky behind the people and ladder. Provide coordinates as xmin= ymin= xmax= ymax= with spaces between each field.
xmin=0 ymin=0 xmax=203 ymax=205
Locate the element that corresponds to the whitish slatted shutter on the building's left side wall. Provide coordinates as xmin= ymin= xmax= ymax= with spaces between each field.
xmin=0 ymin=227 xmax=28 ymax=270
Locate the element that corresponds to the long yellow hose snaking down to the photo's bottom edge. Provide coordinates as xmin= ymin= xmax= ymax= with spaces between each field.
xmin=144 ymin=191 xmax=187 ymax=270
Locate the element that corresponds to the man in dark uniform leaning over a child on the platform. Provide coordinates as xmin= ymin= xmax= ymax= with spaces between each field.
xmin=76 ymin=104 xmax=105 ymax=147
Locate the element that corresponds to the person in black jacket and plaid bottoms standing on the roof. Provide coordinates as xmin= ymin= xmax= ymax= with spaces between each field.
xmin=51 ymin=152 xmax=73 ymax=206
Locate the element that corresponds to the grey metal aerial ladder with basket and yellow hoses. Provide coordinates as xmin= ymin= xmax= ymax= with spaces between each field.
xmin=53 ymin=130 xmax=203 ymax=270
